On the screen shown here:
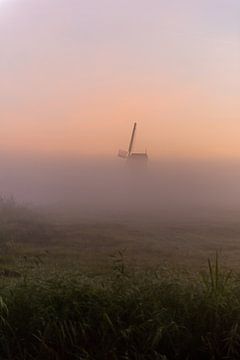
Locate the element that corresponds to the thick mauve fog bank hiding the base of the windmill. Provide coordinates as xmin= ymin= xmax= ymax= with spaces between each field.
xmin=0 ymin=155 xmax=240 ymax=216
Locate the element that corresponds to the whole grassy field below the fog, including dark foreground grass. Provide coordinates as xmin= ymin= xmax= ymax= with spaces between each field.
xmin=0 ymin=199 xmax=240 ymax=360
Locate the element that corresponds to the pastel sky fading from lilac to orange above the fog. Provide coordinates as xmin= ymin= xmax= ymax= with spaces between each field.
xmin=0 ymin=0 xmax=240 ymax=158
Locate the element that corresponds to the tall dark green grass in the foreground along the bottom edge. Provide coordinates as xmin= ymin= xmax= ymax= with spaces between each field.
xmin=0 ymin=260 xmax=240 ymax=360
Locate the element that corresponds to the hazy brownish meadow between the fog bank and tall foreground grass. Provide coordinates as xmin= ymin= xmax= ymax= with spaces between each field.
xmin=3 ymin=205 xmax=240 ymax=271
